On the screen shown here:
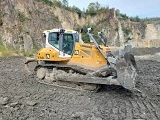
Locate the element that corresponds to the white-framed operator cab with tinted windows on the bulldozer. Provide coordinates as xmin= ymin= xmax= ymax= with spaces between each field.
xmin=43 ymin=29 xmax=79 ymax=58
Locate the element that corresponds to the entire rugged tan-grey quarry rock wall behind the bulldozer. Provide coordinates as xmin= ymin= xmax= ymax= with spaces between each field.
xmin=0 ymin=0 xmax=160 ymax=51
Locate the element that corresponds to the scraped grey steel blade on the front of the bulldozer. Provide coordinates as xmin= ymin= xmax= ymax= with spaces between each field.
xmin=116 ymin=58 xmax=137 ymax=90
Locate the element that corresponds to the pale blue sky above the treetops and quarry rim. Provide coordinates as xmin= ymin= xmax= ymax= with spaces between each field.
xmin=68 ymin=0 xmax=160 ymax=18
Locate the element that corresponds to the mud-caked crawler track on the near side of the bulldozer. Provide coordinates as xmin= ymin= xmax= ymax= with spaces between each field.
xmin=34 ymin=64 xmax=100 ymax=92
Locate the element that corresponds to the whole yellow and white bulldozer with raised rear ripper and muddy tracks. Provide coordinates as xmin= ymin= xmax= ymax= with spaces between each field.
xmin=25 ymin=28 xmax=137 ymax=91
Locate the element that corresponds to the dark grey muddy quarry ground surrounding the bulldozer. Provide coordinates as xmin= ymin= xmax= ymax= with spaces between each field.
xmin=0 ymin=50 xmax=160 ymax=120
